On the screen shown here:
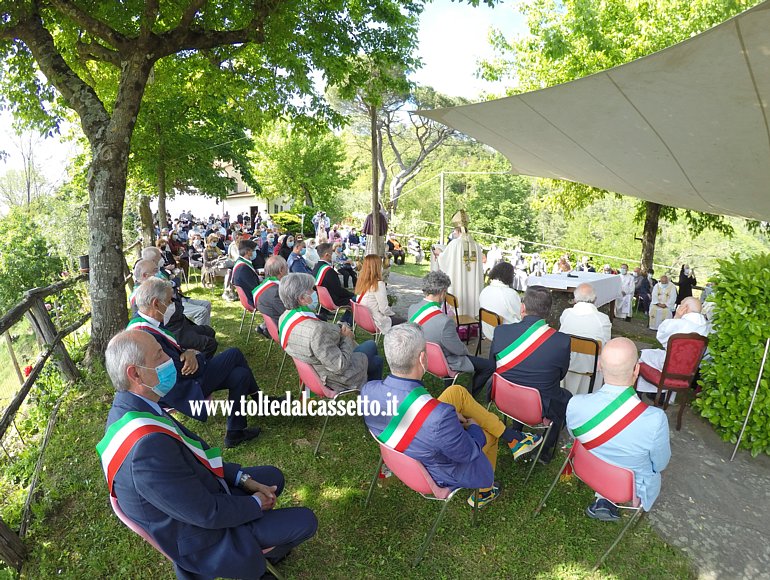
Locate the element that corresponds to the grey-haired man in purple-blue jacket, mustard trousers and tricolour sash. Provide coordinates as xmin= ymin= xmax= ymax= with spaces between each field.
xmin=361 ymin=322 xmax=536 ymax=507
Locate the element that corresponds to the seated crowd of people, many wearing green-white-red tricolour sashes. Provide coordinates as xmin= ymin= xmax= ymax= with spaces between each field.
xmin=103 ymin=212 xmax=710 ymax=578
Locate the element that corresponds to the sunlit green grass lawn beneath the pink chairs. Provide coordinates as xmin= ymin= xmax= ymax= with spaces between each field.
xmin=15 ymin=286 xmax=694 ymax=580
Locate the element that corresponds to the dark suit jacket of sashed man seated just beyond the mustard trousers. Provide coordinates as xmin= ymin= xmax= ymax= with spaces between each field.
xmin=489 ymin=316 xmax=570 ymax=415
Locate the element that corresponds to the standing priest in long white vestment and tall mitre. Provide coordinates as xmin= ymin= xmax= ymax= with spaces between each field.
xmin=438 ymin=210 xmax=484 ymax=317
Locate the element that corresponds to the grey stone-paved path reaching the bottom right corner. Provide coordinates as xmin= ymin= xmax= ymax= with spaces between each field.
xmin=388 ymin=271 xmax=770 ymax=580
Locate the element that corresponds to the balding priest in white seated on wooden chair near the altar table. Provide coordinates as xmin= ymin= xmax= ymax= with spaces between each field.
xmin=559 ymin=284 xmax=612 ymax=395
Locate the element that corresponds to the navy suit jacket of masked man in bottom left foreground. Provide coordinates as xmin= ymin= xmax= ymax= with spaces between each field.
xmin=107 ymin=392 xmax=265 ymax=578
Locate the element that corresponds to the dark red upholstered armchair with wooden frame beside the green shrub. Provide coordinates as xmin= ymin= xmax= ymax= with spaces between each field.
xmin=639 ymin=332 xmax=709 ymax=431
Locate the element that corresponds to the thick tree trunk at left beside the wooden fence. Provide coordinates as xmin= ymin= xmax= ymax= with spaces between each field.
xmin=83 ymin=55 xmax=152 ymax=359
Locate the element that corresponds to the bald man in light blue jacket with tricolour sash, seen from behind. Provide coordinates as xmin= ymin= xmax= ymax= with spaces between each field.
xmin=567 ymin=338 xmax=671 ymax=521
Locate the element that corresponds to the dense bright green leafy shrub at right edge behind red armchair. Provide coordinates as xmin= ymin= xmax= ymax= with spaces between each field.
xmin=694 ymin=254 xmax=770 ymax=456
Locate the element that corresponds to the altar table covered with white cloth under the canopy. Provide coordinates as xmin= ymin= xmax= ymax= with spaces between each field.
xmin=527 ymin=272 xmax=621 ymax=328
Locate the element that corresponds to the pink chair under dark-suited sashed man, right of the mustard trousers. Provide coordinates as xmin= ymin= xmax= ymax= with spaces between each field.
xmin=487 ymin=373 xmax=553 ymax=483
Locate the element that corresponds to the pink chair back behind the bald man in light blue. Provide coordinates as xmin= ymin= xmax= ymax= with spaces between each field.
xmin=572 ymin=439 xmax=638 ymax=504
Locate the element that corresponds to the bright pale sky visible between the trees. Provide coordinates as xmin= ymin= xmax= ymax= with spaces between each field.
xmin=0 ymin=0 xmax=525 ymax=183
